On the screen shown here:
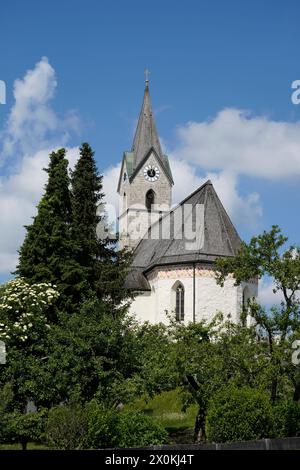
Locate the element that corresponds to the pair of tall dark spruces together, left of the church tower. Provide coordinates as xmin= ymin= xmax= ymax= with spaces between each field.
xmin=16 ymin=143 xmax=130 ymax=312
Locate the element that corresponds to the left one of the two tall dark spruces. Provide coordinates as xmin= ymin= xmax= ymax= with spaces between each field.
xmin=16 ymin=149 xmax=85 ymax=307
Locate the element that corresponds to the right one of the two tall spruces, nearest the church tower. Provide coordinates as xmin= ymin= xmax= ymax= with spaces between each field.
xmin=71 ymin=143 xmax=129 ymax=305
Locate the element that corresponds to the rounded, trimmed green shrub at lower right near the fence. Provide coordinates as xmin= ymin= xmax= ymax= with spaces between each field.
xmin=206 ymin=385 xmax=273 ymax=442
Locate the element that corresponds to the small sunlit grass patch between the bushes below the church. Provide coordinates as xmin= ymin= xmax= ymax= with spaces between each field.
xmin=125 ymin=388 xmax=197 ymax=433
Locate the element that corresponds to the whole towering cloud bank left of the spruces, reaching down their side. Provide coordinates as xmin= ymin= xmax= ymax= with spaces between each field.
xmin=0 ymin=58 xmax=78 ymax=280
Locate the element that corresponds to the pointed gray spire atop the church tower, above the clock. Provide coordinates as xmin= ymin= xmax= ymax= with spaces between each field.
xmin=131 ymin=70 xmax=162 ymax=166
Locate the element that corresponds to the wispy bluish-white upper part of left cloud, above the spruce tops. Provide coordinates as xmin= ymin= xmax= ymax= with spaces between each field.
xmin=0 ymin=57 xmax=79 ymax=164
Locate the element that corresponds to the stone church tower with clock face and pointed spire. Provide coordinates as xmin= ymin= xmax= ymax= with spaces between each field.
xmin=118 ymin=78 xmax=174 ymax=248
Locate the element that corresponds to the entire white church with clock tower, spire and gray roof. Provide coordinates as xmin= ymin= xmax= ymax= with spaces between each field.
xmin=117 ymin=79 xmax=258 ymax=324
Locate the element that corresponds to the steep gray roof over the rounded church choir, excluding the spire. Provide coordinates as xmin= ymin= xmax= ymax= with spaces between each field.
xmin=126 ymin=181 xmax=241 ymax=290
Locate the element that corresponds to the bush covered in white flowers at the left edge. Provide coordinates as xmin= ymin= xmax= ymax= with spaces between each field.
xmin=0 ymin=278 xmax=59 ymax=343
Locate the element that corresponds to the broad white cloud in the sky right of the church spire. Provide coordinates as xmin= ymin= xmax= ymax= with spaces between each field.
xmin=172 ymin=109 xmax=300 ymax=180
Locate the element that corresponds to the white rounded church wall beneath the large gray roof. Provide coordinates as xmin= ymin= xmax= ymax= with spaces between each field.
xmin=126 ymin=266 xmax=257 ymax=324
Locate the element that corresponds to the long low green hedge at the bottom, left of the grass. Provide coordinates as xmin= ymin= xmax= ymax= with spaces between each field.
xmin=46 ymin=400 xmax=167 ymax=449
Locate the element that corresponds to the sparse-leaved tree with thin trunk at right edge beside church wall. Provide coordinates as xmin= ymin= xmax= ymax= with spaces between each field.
xmin=216 ymin=226 xmax=300 ymax=402
